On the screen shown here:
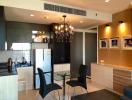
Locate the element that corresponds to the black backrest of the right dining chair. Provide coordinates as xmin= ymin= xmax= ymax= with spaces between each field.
xmin=78 ymin=64 xmax=87 ymax=89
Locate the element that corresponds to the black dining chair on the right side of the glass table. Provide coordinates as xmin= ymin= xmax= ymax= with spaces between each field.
xmin=66 ymin=64 xmax=88 ymax=96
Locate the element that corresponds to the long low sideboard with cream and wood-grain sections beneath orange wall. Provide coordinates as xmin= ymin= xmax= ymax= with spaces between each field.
xmin=91 ymin=63 xmax=132 ymax=94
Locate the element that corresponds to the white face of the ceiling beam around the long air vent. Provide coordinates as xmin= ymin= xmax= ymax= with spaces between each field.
xmin=0 ymin=0 xmax=112 ymax=22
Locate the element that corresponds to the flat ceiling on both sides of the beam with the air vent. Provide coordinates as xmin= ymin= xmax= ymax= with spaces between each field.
xmin=5 ymin=0 xmax=132 ymax=28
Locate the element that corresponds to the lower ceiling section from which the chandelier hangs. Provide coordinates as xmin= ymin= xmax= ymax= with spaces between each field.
xmin=5 ymin=7 xmax=104 ymax=28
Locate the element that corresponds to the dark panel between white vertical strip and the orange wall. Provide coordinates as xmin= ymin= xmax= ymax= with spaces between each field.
xmin=85 ymin=33 xmax=97 ymax=76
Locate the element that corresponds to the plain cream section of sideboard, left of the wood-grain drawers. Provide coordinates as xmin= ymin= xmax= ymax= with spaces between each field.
xmin=91 ymin=64 xmax=113 ymax=89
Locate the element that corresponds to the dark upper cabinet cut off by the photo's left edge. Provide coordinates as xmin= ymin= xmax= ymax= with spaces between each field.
xmin=0 ymin=6 xmax=6 ymax=50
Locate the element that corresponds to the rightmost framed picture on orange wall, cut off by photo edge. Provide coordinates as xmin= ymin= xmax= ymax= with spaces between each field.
xmin=122 ymin=36 xmax=132 ymax=50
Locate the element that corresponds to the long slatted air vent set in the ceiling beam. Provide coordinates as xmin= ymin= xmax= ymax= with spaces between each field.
xmin=44 ymin=3 xmax=86 ymax=16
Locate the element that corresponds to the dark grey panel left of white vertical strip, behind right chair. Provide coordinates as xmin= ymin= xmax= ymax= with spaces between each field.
xmin=70 ymin=32 xmax=83 ymax=74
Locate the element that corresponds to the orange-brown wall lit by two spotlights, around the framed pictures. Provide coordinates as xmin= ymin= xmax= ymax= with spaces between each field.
xmin=98 ymin=9 xmax=132 ymax=68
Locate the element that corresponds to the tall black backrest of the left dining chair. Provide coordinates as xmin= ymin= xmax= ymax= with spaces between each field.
xmin=38 ymin=68 xmax=46 ymax=97
